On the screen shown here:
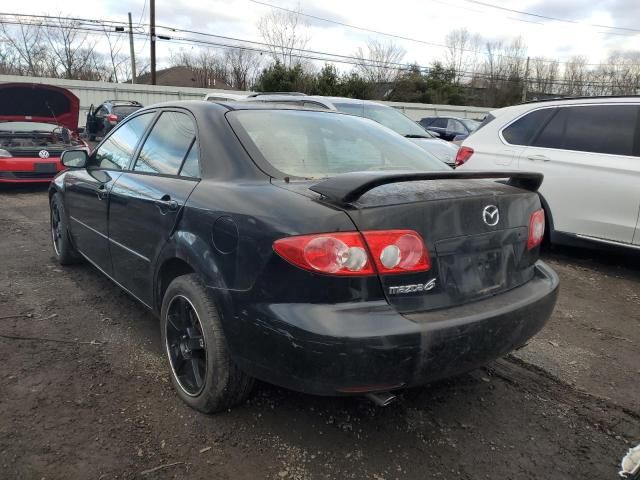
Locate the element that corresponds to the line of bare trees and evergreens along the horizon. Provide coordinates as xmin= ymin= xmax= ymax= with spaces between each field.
xmin=0 ymin=10 xmax=640 ymax=107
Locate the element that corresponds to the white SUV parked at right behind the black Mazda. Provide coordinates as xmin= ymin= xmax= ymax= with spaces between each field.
xmin=456 ymin=97 xmax=640 ymax=249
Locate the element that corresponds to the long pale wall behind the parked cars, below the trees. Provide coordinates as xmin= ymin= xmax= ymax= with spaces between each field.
xmin=0 ymin=75 xmax=492 ymax=125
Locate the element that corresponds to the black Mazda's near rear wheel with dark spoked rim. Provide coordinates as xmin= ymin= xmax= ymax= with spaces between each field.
xmin=160 ymin=274 xmax=253 ymax=413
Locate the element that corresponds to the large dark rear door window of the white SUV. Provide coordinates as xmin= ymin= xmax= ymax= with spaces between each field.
xmin=534 ymin=105 xmax=640 ymax=156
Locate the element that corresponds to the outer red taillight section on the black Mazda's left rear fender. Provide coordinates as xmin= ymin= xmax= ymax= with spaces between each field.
xmin=273 ymin=232 xmax=374 ymax=275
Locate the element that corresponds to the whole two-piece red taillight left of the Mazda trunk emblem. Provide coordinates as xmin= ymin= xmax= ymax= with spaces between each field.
xmin=273 ymin=230 xmax=431 ymax=276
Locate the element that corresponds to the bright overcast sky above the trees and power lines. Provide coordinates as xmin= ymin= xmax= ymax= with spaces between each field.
xmin=8 ymin=0 xmax=640 ymax=69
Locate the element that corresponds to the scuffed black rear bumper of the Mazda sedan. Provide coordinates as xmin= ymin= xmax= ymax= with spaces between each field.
xmin=225 ymin=262 xmax=558 ymax=395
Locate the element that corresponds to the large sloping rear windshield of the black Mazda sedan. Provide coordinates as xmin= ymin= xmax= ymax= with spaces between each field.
xmin=228 ymin=110 xmax=449 ymax=178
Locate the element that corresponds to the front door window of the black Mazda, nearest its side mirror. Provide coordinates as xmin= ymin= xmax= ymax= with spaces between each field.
xmin=94 ymin=112 xmax=155 ymax=170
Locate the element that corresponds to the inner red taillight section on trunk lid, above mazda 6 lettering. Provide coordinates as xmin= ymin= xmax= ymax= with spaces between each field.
xmin=363 ymin=230 xmax=431 ymax=274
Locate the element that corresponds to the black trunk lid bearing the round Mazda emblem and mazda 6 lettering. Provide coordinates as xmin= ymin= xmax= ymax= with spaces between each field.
xmin=278 ymin=172 xmax=541 ymax=312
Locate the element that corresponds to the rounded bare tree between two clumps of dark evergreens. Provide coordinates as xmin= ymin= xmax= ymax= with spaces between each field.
xmin=354 ymin=39 xmax=406 ymax=98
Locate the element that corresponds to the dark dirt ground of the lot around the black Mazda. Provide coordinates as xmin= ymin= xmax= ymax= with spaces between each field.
xmin=0 ymin=187 xmax=640 ymax=480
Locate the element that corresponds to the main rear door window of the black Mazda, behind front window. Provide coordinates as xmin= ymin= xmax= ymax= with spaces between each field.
xmin=133 ymin=112 xmax=196 ymax=175
